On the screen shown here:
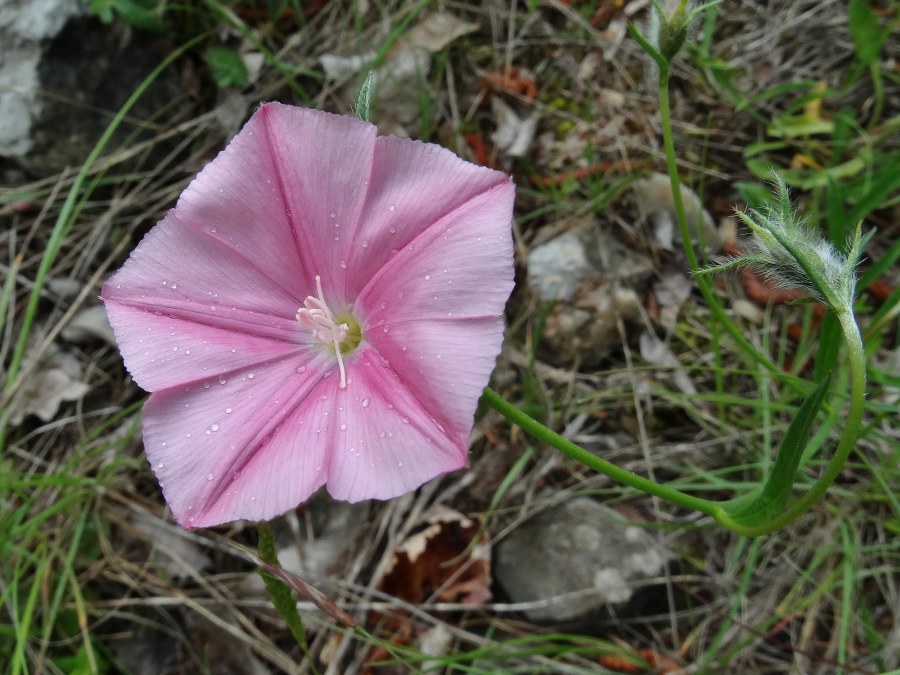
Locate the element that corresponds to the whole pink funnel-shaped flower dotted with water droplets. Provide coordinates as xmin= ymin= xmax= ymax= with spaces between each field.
xmin=103 ymin=103 xmax=514 ymax=527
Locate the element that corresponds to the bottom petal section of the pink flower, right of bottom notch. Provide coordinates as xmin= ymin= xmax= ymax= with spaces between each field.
xmin=322 ymin=347 xmax=472 ymax=502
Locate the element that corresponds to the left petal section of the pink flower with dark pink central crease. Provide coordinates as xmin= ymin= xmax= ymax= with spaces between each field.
xmin=102 ymin=212 xmax=309 ymax=391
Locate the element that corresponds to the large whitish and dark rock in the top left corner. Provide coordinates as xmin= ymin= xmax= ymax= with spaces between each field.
xmin=0 ymin=0 xmax=182 ymax=174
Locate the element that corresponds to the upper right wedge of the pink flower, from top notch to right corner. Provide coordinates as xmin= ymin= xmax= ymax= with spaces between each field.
xmin=348 ymin=136 xmax=513 ymax=294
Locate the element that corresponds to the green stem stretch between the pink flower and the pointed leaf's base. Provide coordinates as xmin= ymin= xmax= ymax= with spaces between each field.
xmin=481 ymin=387 xmax=722 ymax=520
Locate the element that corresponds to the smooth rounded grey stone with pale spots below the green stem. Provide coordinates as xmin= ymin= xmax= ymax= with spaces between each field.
xmin=493 ymin=497 xmax=668 ymax=622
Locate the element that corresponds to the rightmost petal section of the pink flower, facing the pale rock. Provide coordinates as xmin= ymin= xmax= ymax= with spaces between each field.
xmin=357 ymin=182 xmax=514 ymax=443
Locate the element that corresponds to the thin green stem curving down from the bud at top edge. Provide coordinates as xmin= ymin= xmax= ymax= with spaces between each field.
xmin=657 ymin=66 xmax=804 ymax=388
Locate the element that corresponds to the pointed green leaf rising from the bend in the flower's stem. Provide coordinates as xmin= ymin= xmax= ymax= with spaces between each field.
xmin=722 ymin=373 xmax=831 ymax=528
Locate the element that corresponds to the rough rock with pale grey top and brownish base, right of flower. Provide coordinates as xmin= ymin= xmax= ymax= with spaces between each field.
xmin=528 ymin=220 xmax=653 ymax=367
